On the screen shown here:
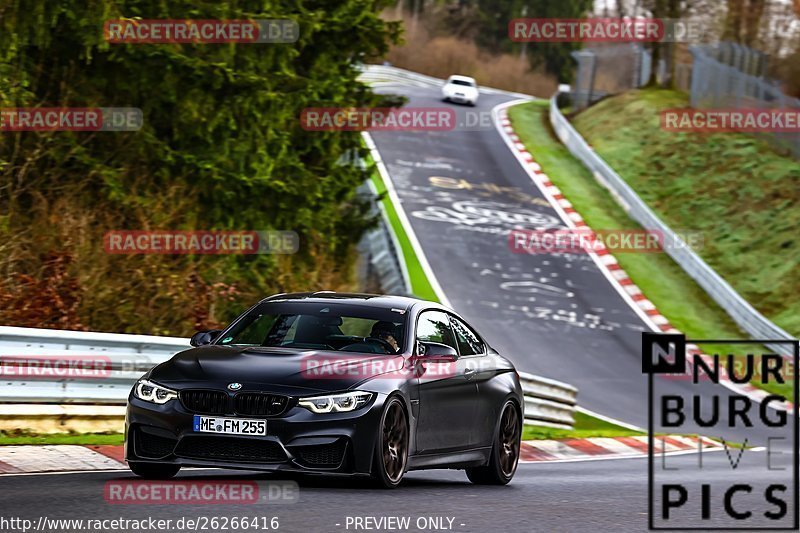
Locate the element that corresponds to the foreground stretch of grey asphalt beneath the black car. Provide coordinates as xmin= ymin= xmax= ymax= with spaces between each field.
xmin=0 ymin=452 xmax=792 ymax=533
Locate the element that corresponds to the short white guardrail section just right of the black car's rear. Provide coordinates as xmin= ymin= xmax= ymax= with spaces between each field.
xmin=519 ymin=372 xmax=578 ymax=429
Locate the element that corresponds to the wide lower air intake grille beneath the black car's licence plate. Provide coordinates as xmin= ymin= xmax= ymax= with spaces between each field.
xmin=175 ymin=437 xmax=286 ymax=463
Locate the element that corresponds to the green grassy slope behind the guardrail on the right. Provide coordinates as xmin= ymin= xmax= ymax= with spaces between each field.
xmin=574 ymin=89 xmax=800 ymax=335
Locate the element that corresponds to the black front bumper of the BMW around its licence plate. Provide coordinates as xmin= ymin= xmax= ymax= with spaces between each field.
xmin=125 ymin=394 xmax=385 ymax=474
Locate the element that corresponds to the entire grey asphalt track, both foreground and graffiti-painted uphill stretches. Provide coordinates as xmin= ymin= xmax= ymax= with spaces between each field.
xmin=0 ymin=80 xmax=792 ymax=532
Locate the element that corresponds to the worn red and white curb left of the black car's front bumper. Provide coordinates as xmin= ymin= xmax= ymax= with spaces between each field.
xmin=0 ymin=444 xmax=128 ymax=474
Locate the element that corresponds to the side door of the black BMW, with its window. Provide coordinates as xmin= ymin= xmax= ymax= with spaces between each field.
xmin=415 ymin=310 xmax=478 ymax=453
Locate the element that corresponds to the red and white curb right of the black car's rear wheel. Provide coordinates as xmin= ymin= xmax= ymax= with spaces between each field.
xmin=520 ymin=435 xmax=724 ymax=463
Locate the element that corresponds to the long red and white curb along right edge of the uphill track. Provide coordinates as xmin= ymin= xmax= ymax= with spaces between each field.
xmin=493 ymin=101 xmax=793 ymax=410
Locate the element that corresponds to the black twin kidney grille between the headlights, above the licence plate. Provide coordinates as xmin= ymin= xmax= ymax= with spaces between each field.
xmin=179 ymin=389 xmax=289 ymax=416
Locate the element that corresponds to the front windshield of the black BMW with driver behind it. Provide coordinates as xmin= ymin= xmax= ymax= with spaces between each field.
xmin=217 ymin=302 xmax=406 ymax=353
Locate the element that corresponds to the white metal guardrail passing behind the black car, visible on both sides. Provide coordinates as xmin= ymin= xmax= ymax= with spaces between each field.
xmin=0 ymin=326 xmax=577 ymax=428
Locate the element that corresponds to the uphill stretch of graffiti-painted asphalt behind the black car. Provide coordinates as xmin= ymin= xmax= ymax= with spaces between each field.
xmin=371 ymin=85 xmax=790 ymax=445
